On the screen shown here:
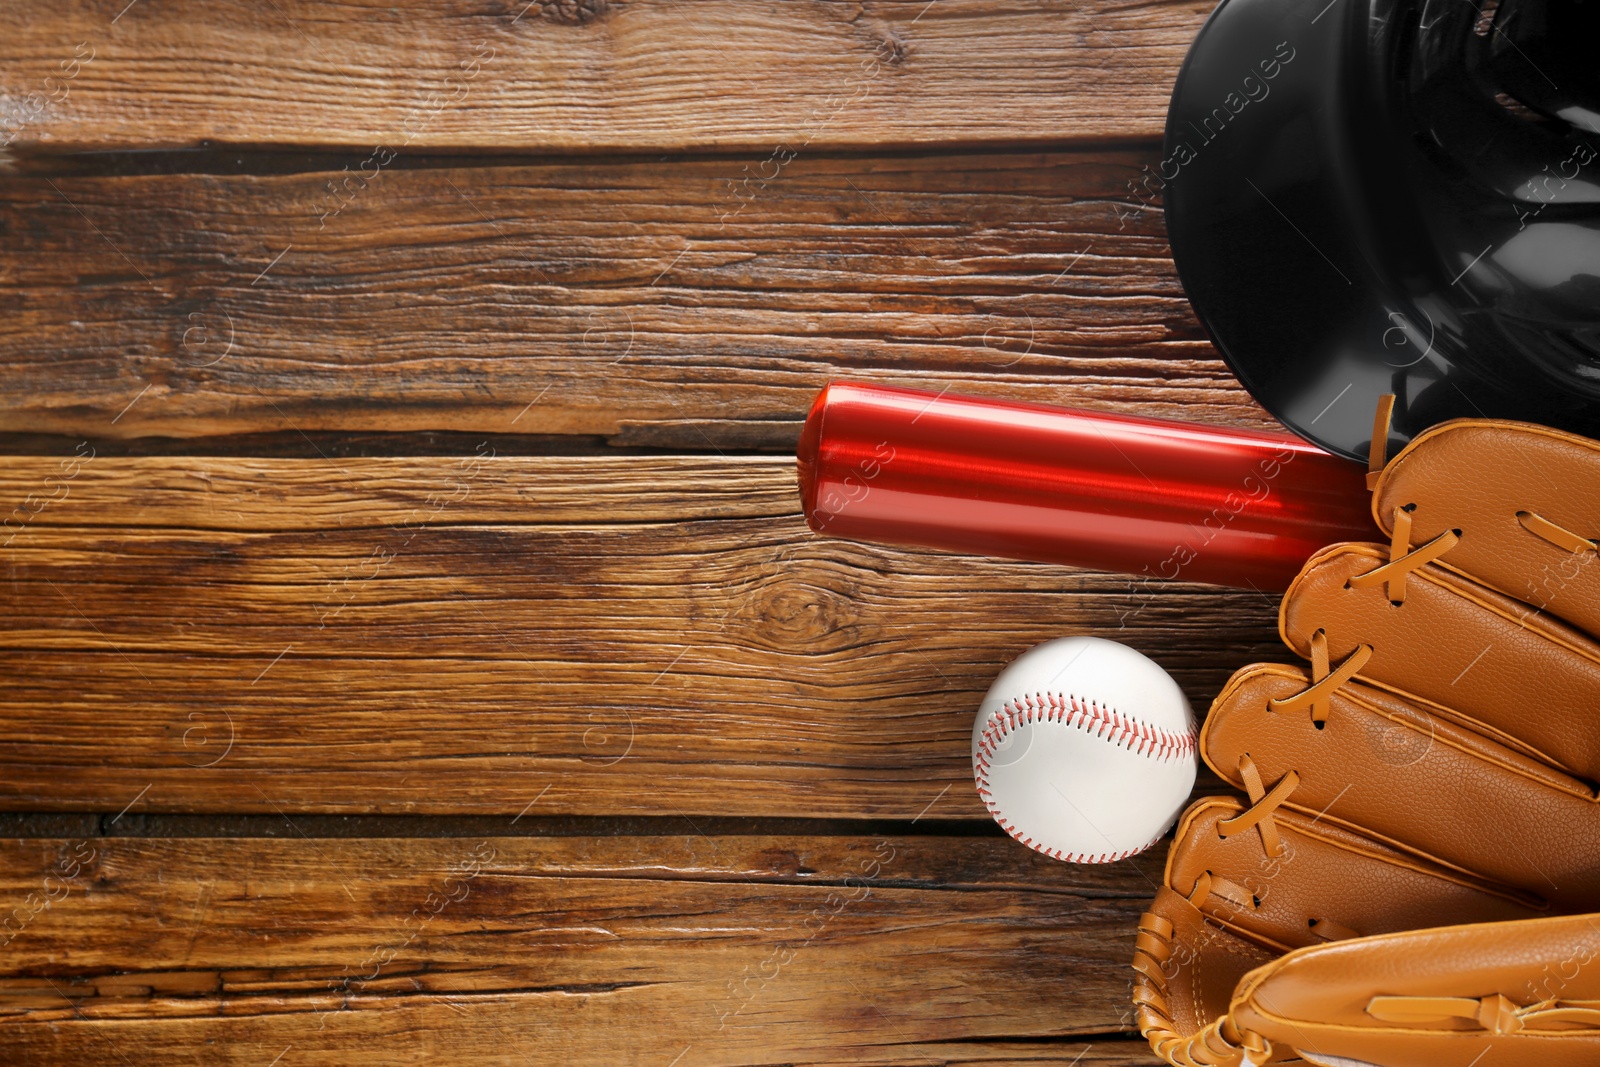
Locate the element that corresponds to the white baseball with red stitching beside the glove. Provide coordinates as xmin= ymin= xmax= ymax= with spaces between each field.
xmin=973 ymin=637 xmax=1195 ymax=864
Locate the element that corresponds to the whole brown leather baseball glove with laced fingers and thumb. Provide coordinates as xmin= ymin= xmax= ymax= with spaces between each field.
xmin=1133 ymin=404 xmax=1600 ymax=1067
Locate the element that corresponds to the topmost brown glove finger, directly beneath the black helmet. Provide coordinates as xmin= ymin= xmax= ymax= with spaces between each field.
xmin=1373 ymin=419 xmax=1600 ymax=635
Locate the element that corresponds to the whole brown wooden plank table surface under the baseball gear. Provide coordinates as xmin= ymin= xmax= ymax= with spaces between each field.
xmin=0 ymin=0 xmax=1277 ymax=1067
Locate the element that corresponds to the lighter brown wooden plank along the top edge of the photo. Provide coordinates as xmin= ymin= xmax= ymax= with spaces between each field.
xmin=0 ymin=0 xmax=1210 ymax=155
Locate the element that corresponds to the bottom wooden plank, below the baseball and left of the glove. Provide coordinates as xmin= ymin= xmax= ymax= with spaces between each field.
xmin=0 ymin=835 xmax=1160 ymax=1065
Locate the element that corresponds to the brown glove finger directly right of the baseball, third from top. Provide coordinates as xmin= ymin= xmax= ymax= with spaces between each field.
xmin=1200 ymin=664 xmax=1600 ymax=912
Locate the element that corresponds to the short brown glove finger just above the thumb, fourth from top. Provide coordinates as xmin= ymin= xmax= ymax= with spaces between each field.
xmin=1166 ymin=797 xmax=1546 ymax=952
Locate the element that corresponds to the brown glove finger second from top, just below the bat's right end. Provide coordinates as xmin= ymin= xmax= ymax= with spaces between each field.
xmin=1278 ymin=544 xmax=1600 ymax=781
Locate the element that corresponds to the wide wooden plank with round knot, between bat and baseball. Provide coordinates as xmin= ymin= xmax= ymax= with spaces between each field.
xmin=0 ymin=456 xmax=1282 ymax=819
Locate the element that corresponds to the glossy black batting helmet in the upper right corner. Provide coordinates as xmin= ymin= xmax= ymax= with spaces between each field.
xmin=1164 ymin=0 xmax=1600 ymax=459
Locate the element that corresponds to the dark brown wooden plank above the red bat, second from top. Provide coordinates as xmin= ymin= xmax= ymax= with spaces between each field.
xmin=0 ymin=150 xmax=1275 ymax=450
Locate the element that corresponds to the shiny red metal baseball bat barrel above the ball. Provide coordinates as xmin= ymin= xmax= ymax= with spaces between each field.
xmin=797 ymin=382 xmax=1378 ymax=590
